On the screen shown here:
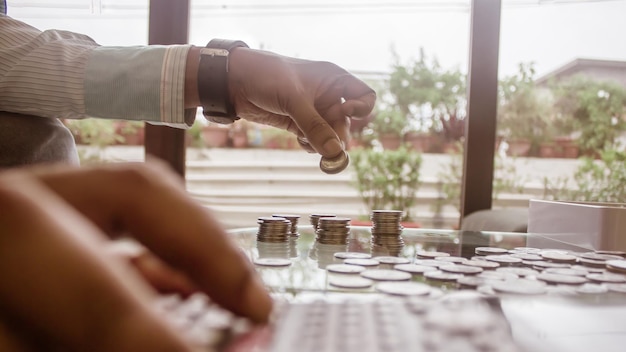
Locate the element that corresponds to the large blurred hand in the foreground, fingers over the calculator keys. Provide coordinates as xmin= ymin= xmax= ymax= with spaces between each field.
xmin=0 ymin=163 xmax=271 ymax=352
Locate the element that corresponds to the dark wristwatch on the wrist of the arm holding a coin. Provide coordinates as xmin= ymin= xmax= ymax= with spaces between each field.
xmin=198 ymin=39 xmax=248 ymax=124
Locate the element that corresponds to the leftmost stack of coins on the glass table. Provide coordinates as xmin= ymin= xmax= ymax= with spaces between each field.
xmin=256 ymin=216 xmax=291 ymax=258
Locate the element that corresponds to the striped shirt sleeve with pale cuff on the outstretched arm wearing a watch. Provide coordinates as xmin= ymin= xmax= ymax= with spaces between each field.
xmin=0 ymin=14 xmax=196 ymax=127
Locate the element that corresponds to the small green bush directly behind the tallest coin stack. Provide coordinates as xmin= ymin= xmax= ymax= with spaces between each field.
xmin=350 ymin=147 xmax=422 ymax=221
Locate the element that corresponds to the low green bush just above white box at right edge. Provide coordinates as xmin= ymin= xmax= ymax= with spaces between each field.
xmin=543 ymin=146 xmax=626 ymax=203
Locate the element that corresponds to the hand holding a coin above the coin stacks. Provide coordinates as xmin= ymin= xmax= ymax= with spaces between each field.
xmin=228 ymin=48 xmax=376 ymax=157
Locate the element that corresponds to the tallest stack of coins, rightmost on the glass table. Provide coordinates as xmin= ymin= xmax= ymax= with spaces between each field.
xmin=370 ymin=210 xmax=404 ymax=256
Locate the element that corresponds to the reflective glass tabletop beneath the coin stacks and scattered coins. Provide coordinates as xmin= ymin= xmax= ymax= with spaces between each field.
xmin=230 ymin=225 xmax=626 ymax=351
